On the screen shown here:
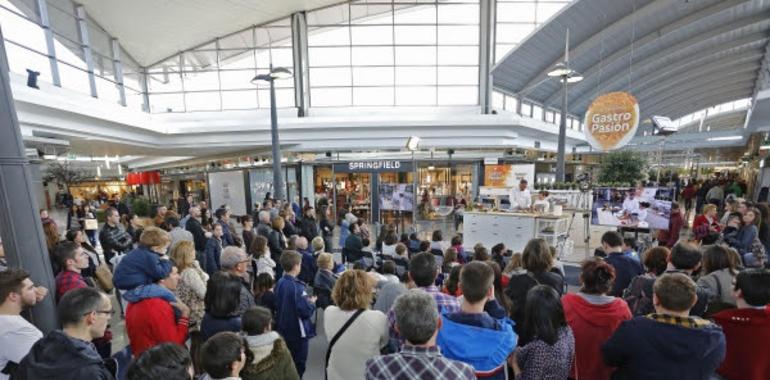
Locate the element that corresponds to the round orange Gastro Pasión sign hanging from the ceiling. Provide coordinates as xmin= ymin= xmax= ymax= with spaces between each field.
xmin=585 ymin=92 xmax=639 ymax=151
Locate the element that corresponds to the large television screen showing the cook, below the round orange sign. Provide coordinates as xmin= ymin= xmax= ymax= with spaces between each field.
xmin=591 ymin=187 xmax=673 ymax=230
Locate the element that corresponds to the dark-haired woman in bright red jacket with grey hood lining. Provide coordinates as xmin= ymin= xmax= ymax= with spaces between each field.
xmin=562 ymin=258 xmax=631 ymax=380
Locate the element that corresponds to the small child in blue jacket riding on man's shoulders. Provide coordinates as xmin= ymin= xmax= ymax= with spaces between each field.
xmin=112 ymin=227 xmax=172 ymax=290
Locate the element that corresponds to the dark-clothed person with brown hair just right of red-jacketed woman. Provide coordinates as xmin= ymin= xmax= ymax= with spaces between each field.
xmin=623 ymin=246 xmax=671 ymax=316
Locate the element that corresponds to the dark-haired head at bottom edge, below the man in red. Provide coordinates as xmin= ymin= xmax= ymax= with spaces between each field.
xmin=126 ymin=343 xmax=194 ymax=380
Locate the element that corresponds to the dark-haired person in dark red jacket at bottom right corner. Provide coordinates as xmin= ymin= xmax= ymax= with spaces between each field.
xmin=714 ymin=269 xmax=770 ymax=380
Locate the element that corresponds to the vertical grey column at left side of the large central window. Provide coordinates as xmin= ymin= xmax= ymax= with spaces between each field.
xmin=291 ymin=12 xmax=310 ymax=117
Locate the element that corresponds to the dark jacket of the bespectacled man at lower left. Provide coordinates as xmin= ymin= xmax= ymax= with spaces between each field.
xmin=24 ymin=330 xmax=104 ymax=379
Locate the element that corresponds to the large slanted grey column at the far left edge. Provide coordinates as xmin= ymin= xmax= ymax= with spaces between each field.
xmin=0 ymin=30 xmax=58 ymax=333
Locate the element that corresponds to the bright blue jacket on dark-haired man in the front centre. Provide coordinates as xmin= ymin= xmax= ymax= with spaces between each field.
xmin=436 ymin=316 xmax=518 ymax=372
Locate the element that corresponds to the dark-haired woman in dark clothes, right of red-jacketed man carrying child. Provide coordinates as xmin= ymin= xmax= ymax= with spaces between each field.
xmin=201 ymin=271 xmax=243 ymax=340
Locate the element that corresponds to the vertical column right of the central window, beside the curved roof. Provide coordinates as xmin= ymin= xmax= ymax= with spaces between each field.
xmin=479 ymin=0 xmax=497 ymax=114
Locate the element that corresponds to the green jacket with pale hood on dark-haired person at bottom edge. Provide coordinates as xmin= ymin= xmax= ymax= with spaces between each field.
xmin=241 ymin=331 xmax=299 ymax=380
